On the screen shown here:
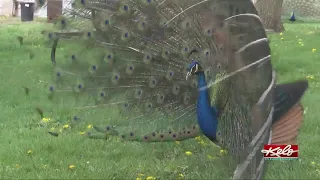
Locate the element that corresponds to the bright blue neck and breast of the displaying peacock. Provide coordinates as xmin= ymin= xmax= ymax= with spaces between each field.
xmin=197 ymin=72 xmax=218 ymax=141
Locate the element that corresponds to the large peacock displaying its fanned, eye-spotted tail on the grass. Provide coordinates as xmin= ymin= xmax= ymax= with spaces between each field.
xmin=38 ymin=0 xmax=308 ymax=169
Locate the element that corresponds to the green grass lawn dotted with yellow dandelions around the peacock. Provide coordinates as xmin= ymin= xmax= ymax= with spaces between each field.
xmin=0 ymin=19 xmax=320 ymax=179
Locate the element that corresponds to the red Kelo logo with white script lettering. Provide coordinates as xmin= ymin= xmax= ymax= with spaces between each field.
xmin=261 ymin=144 xmax=299 ymax=160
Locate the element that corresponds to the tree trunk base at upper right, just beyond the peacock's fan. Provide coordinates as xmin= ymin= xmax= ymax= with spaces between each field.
xmin=255 ymin=0 xmax=284 ymax=32
